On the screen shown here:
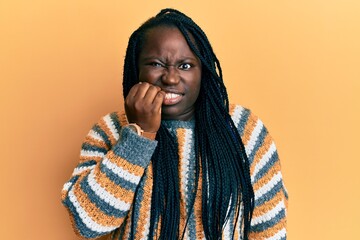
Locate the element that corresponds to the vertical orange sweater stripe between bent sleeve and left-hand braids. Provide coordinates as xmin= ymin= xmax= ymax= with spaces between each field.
xmin=135 ymin=163 xmax=153 ymax=239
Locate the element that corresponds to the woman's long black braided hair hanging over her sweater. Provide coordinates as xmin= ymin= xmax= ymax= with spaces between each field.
xmin=123 ymin=9 xmax=254 ymax=239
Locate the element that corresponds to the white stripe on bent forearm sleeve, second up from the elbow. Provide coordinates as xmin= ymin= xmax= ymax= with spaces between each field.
xmin=88 ymin=172 xmax=130 ymax=211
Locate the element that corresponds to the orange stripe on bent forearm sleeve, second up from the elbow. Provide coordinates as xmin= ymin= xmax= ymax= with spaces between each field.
xmin=94 ymin=165 xmax=134 ymax=203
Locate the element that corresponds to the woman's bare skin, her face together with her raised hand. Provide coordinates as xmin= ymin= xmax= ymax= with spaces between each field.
xmin=125 ymin=26 xmax=201 ymax=133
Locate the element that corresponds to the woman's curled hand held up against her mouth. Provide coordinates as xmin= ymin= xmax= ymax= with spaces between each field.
xmin=125 ymin=82 xmax=165 ymax=132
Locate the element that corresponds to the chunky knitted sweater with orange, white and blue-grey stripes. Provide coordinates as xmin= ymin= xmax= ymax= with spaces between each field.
xmin=62 ymin=105 xmax=287 ymax=240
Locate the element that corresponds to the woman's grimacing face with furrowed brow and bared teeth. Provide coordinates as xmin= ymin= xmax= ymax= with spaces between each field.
xmin=138 ymin=26 xmax=201 ymax=121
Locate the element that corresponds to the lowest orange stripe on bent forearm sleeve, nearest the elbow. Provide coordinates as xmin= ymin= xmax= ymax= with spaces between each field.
xmin=73 ymin=177 xmax=123 ymax=227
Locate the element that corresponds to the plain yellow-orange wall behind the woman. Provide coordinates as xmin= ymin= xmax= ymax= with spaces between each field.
xmin=0 ymin=0 xmax=360 ymax=240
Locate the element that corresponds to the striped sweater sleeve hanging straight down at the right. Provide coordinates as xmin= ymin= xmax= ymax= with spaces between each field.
xmin=233 ymin=106 xmax=288 ymax=240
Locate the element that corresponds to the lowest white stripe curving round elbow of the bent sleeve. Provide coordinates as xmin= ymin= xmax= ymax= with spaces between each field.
xmin=69 ymin=188 xmax=118 ymax=233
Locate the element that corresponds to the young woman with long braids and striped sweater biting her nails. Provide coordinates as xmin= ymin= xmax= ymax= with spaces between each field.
xmin=62 ymin=9 xmax=287 ymax=239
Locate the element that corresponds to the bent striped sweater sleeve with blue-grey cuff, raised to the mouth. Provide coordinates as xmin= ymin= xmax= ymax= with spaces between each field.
xmin=62 ymin=113 xmax=157 ymax=238
